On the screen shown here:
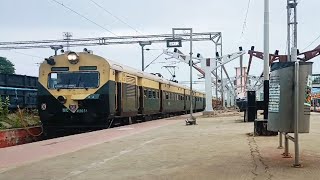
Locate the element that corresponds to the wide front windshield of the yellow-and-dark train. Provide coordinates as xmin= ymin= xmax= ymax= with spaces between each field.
xmin=48 ymin=72 xmax=99 ymax=89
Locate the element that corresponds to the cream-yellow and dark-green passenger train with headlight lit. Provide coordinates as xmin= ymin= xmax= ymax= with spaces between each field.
xmin=38 ymin=51 xmax=205 ymax=135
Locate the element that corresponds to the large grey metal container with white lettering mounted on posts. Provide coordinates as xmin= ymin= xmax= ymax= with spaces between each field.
xmin=267 ymin=62 xmax=312 ymax=133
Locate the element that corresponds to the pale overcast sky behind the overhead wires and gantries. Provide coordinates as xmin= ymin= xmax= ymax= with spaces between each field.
xmin=0 ymin=0 xmax=320 ymax=90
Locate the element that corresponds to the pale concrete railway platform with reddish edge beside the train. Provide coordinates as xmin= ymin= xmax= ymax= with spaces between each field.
xmin=0 ymin=112 xmax=320 ymax=180
